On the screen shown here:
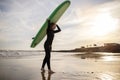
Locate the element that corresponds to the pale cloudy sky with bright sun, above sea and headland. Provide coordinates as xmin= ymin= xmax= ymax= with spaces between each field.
xmin=0 ymin=0 xmax=120 ymax=50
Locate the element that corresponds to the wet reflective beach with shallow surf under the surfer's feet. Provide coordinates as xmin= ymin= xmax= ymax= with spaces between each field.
xmin=0 ymin=51 xmax=120 ymax=80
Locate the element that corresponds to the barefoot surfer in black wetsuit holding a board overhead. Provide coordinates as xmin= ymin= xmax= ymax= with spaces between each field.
xmin=41 ymin=19 xmax=61 ymax=73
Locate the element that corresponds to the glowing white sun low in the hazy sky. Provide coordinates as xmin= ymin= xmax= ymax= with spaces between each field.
xmin=91 ymin=12 xmax=118 ymax=36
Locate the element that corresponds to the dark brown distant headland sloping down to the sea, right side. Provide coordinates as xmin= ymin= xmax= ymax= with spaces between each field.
xmin=54 ymin=43 xmax=120 ymax=53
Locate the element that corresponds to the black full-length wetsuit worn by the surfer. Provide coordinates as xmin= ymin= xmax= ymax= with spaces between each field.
xmin=42 ymin=20 xmax=61 ymax=70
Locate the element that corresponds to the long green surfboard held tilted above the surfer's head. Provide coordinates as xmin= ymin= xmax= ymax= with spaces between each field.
xmin=31 ymin=0 xmax=70 ymax=48
